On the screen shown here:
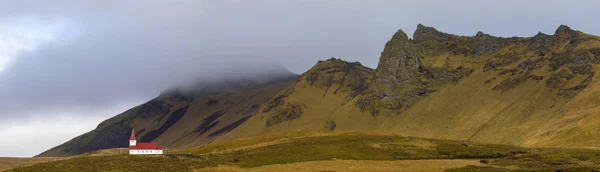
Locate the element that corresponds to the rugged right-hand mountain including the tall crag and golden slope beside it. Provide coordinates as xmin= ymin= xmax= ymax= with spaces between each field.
xmin=366 ymin=25 xmax=600 ymax=146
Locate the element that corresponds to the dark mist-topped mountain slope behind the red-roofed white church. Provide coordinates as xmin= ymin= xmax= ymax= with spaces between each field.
xmin=37 ymin=71 xmax=297 ymax=157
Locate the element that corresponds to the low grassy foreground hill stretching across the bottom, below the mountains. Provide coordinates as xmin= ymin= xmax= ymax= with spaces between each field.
xmin=8 ymin=131 xmax=600 ymax=171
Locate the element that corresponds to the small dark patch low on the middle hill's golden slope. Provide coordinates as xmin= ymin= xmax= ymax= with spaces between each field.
xmin=265 ymin=103 xmax=305 ymax=127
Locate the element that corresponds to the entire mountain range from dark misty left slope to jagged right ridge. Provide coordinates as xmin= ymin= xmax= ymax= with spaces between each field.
xmin=40 ymin=24 xmax=600 ymax=156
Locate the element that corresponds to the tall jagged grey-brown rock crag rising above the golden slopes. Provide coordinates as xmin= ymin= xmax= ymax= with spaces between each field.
xmin=357 ymin=24 xmax=474 ymax=116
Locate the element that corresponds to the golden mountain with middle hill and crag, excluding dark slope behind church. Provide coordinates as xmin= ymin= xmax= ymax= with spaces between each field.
xmin=218 ymin=25 xmax=600 ymax=147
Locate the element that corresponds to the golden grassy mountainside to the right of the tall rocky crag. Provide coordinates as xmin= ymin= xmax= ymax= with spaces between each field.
xmin=370 ymin=26 xmax=600 ymax=146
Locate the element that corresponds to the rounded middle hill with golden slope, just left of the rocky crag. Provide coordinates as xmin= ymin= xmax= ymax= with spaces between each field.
xmin=217 ymin=58 xmax=373 ymax=140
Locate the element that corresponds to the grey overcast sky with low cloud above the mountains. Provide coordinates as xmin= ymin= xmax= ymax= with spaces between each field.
xmin=0 ymin=0 xmax=600 ymax=157
